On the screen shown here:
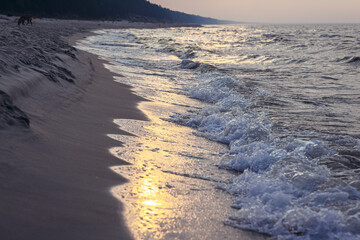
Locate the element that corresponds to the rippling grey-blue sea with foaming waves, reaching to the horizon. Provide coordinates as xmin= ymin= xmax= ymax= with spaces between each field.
xmin=80 ymin=24 xmax=360 ymax=239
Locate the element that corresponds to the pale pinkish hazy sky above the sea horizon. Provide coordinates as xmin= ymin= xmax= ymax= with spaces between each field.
xmin=150 ymin=0 xmax=360 ymax=23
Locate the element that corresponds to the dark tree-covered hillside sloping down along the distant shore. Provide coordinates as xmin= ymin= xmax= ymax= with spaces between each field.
xmin=0 ymin=0 xmax=225 ymax=24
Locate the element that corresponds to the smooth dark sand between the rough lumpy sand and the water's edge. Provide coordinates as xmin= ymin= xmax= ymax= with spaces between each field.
xmin=0 ymin=19 xmax=155 ymax=240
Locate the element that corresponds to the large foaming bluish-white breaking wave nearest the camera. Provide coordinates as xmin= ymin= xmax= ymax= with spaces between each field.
xmin=168 ymin=72 xmax=360 ymax=239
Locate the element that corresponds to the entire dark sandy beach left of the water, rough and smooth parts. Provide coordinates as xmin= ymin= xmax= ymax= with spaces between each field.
xmin=0 ymin=18 xmax=179 ymax=240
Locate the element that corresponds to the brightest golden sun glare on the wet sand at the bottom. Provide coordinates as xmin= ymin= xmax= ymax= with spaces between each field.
xmin=111 ymin=144 xmax=177 ymax=239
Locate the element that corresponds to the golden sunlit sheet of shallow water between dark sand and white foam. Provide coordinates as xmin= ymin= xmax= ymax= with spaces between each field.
xmin=109 ymin=102 xmax=266 ymax=239
